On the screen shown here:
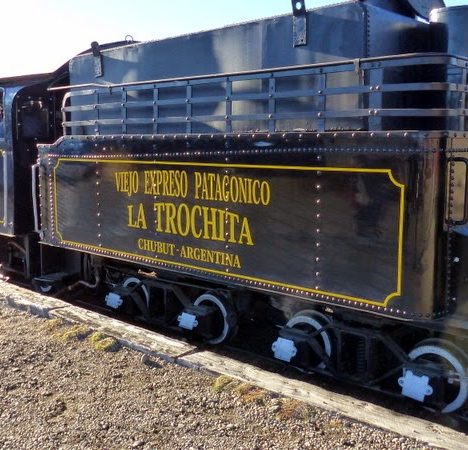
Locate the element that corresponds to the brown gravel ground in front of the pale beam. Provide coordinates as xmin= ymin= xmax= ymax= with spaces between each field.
xmin=0 ymin=296 xmax=450 ymax=450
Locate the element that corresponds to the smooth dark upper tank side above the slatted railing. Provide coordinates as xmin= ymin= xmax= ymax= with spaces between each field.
xmin=70 ymin=2 xmax=431 ymax=92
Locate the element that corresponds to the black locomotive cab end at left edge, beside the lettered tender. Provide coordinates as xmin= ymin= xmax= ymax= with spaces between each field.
xmin=0 ymin=66 xmax=68 ymax=280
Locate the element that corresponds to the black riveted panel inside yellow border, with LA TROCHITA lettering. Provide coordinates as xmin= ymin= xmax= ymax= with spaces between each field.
xmin=50 ymin=157 xmax=405 ymax=306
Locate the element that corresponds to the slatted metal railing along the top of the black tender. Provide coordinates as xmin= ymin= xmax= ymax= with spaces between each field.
xmin=60 ymin=54 xmax=468 ymax=135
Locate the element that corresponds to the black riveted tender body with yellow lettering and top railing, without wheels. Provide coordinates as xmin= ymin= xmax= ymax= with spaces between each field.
xmin=33 ymin=2 xmax=468 ymax=326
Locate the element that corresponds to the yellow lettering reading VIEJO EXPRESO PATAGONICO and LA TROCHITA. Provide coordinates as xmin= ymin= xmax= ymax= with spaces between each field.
xmin=115 ymin=170 xmax=271 ymax=245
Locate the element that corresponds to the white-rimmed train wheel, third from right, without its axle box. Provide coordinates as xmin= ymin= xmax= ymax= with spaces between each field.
xmin=194 ymin=292 xmax=238 ymax=345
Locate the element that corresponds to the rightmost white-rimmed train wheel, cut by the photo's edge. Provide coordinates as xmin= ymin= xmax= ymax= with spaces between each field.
xmin=399 ymin=339 xmax=468 ymax=413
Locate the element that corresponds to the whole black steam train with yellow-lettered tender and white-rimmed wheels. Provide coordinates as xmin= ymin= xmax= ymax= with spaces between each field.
xmin=0 ymin=0 xmax=468 ymax=414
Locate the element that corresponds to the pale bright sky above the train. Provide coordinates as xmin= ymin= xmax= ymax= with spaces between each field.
xmin=0 ymin=0 xmax=468 ymax=77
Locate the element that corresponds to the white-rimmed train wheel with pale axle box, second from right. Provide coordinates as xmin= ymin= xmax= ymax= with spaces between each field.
xmin=272 ymin=310 xmax=332 ymax=369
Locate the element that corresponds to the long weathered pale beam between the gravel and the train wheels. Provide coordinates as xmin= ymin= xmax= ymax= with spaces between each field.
xmin=0 ymin=282 xmax=468 ymax=449
